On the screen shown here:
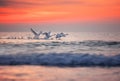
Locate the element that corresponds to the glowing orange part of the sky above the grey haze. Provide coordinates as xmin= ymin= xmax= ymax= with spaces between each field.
xmin=0 ymin=0 xmax=120 ymax=23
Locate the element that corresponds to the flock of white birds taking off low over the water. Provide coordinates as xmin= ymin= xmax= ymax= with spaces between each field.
xmin=7 ymin=28 xmax=68 ymax=40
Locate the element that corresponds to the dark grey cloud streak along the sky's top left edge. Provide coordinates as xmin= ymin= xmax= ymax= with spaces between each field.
xmin=0 ymin=0 xmax=83 ymax=8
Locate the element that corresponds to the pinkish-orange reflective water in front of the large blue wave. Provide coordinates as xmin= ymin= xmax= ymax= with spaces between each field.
xmin=0 ymin=66 xmax=120 ymax=81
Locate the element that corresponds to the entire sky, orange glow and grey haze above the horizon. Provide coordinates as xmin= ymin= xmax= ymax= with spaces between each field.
xmin=0 ymin=0 xmax=120 ymax=31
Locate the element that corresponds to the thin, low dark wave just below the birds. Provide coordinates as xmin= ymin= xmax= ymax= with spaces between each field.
xmin=0 ymin=40 xmax=120 ymax=46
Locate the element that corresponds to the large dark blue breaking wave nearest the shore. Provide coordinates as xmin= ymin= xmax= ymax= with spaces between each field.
xmin=0 ymin=53 xmax=120 ymax=67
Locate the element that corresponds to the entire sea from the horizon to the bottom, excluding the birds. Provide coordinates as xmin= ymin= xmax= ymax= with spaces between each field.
xmin=0 ymin=32 xmax=120 ymax=81
